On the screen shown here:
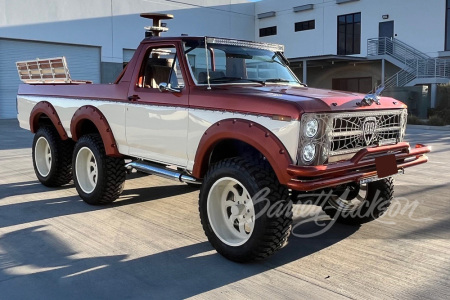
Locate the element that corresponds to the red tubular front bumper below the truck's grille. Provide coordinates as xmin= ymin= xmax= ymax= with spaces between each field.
xmin=287 ymin=142 xmax=431 ymax=191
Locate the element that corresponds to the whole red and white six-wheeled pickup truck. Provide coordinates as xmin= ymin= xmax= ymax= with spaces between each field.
xmin=17 ymin=14 xmax=430 ymax=262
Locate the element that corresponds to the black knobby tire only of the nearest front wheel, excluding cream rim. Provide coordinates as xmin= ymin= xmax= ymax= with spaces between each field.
xmin=199 ymin=157 xmax=292 ymax=262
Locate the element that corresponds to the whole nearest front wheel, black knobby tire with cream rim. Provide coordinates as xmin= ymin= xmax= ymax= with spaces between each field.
xmin=199 ymin=158 xmax=292 ymax=262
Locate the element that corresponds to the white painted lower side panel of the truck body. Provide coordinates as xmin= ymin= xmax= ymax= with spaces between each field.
xmin=18 ymin=96 xmax=300 ymax=171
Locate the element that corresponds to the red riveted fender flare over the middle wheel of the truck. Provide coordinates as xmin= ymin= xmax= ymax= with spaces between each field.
xmin=70 ymin=105 xmax=122 ymax=157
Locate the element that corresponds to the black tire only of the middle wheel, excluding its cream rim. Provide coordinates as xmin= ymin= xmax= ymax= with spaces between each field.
xmin=72 ymin=134 xmax=126 ymax=205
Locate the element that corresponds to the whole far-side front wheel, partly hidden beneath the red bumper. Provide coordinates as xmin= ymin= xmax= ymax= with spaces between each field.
xmin=323 ymin=177 xmax=394 ymax=225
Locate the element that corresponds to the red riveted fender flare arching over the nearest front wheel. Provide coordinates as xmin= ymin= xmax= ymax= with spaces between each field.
xmin=192 ymin=119 xmax=292 ymax=184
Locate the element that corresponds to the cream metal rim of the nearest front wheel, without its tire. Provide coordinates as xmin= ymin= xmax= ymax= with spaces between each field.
xmin=206 ymin=177 xmax=255 ymax=247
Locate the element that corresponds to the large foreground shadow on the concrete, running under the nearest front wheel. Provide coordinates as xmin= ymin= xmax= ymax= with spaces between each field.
xmin=0 ymin=219 xmax=357 ymax=299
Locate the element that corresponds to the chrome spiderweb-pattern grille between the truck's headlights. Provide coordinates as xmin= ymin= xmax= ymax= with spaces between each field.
xmin=329 ymin=110 xmax=406 ymax=156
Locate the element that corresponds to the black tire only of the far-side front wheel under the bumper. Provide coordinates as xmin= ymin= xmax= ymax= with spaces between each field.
xmin=322 ymin=177 xmax=394 ymax=225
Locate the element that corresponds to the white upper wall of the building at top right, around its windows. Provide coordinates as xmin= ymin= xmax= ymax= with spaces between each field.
xmin=255 ymin=0 xmax=446 ymax=58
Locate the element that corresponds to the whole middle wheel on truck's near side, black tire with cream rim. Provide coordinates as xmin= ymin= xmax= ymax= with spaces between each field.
xmin=72 ymin=134 xmax=126 ymax=205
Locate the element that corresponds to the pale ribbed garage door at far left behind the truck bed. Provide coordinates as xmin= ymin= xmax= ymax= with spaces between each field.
xmin=0 ymin=39 xmax=101 ymax=119
